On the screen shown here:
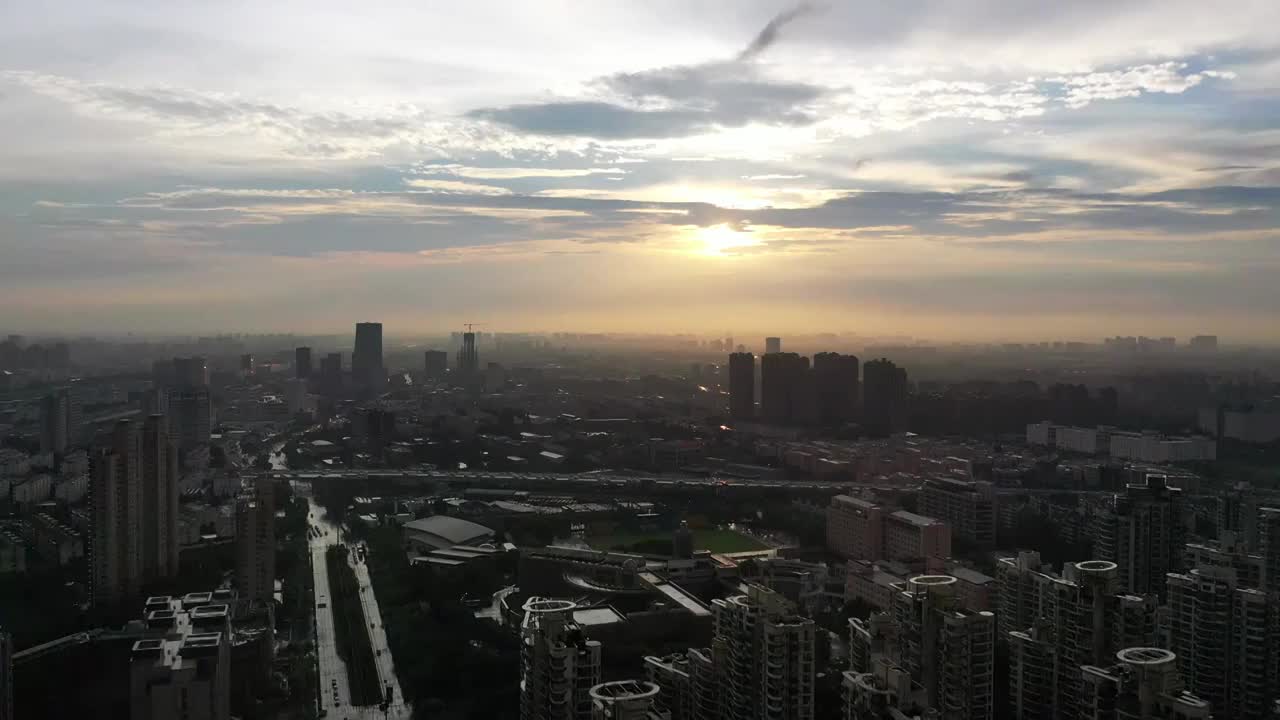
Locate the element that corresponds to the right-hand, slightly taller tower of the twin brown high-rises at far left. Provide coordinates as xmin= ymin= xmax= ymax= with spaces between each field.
xmin=138 ymin=415 xmax=178 ymax=582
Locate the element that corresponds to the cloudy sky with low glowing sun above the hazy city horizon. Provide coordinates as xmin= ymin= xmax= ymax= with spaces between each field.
xmin=0 ymin=0 xmax=1280 ymax=342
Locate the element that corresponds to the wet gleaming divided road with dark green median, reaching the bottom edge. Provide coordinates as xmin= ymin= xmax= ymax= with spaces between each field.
xmin=304 ymin=488 xmax=412 ymax=720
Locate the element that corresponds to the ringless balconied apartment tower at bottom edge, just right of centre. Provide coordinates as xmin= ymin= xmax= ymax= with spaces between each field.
xmin=712 ymin=584 xmax=815 ymax=720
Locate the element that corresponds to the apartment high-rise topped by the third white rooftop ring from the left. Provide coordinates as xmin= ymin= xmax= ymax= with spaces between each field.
xmin=846 ymin=575 xmax=996 ymax=720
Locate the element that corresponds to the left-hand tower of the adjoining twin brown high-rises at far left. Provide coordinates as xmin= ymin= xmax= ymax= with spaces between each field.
xmin=90 ymin=420 xmax=142 ymax=605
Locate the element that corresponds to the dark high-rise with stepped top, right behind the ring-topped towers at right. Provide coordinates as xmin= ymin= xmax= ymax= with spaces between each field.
xmin=1094 ymin=474 xmax=1187 ymax=597
